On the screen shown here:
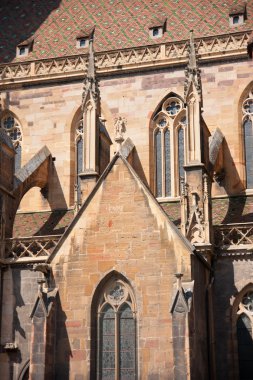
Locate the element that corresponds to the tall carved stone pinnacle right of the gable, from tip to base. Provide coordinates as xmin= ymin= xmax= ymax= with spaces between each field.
xmin=181 ymin=31 xmax=212 ymax=260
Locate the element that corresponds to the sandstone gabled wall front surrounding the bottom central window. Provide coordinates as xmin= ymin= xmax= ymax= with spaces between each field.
xmin=48 ymin=152 xmax=193 ymax=378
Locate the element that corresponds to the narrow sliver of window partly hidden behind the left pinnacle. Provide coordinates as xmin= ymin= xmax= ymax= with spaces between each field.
xmin=75 ymin=120 xmax=84 ymax=205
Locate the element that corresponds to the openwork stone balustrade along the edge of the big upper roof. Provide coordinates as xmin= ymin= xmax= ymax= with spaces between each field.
xmin=0 ymin=31 xmax=251 ymax=89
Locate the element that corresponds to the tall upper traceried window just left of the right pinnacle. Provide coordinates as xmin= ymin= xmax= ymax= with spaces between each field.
xmin=153 ymin=96 xmax=186 ymax=197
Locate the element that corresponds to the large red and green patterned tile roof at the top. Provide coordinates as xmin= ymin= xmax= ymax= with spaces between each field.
xmin=0 ymin=0 xmax=253 ymax=62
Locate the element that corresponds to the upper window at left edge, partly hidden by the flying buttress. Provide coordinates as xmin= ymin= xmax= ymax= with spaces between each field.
xmin=0 ymin=112 xmax=22 ymax=172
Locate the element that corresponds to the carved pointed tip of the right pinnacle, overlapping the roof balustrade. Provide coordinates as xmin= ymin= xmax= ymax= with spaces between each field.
xmin=184 ymin=30 xmax=202 ymax=100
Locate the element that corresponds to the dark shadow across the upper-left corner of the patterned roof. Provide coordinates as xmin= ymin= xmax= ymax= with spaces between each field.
xmin=0 ymin=0 xmax=61 ymax=63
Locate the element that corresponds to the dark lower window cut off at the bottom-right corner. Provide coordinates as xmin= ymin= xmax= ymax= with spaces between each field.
xmin=236 ymin=291 xmax=253 ymax=380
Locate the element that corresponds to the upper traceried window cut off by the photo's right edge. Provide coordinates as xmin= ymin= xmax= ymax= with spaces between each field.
xmin=242 ymin=89 xmax=253 ymax=189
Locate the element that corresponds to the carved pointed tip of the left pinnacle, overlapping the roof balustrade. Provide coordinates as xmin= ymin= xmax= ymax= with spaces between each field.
xmin=82 ymin=29 xmax=98 ymax=111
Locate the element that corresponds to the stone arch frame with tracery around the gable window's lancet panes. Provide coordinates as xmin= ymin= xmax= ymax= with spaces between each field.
xmin=90 ymin=270 xmax=137 ymax=379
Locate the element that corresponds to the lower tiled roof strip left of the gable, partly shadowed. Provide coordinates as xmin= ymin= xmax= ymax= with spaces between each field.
xmin=13 ymin=210 xmax=74 ymax=237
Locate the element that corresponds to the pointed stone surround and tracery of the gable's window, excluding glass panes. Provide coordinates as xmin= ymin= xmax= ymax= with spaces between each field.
xmin=90 ymin=271 xmax=137 ymax=380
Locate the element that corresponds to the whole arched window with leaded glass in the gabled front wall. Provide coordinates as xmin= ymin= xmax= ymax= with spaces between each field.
xmin=97 ymin=279 xmax=137 ymax=380
